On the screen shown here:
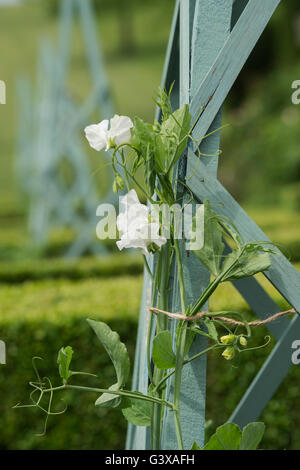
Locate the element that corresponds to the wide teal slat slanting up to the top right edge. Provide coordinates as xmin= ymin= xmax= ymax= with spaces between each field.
xmin=191 ymin=0 xmax=280 ymax=143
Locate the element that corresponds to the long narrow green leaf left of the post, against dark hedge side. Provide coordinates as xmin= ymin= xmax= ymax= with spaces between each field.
xmin=87 ymin=320 xmax=130 ymax=388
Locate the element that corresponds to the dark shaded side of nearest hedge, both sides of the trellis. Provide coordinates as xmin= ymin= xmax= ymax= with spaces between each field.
xmin=0 ymin=311 xmax=300 ymax=449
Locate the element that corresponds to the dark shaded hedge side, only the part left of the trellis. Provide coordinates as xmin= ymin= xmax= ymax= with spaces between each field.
xmin=0 ymin=316 xmax=136 ymax=449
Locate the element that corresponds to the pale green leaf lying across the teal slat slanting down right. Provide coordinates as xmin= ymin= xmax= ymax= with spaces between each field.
xmin=222 ymin=248 xmax=271 ymax=282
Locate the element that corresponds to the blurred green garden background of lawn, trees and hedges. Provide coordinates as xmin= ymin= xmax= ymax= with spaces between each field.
xmin=0 ymin=0 xmax=300 ymax=449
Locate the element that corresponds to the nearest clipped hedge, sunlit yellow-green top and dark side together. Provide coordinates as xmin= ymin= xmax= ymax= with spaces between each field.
xmin=0 ymin=276 xmax=300 ymax=449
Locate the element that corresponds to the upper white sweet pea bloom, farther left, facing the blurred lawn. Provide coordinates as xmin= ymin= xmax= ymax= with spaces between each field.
xmin=84 ymin=114 xmax=133 ymax=151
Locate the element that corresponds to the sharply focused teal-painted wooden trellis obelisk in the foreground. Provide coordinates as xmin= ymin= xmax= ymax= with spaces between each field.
xmin=128 ymin=0 xmax=300 ymax=449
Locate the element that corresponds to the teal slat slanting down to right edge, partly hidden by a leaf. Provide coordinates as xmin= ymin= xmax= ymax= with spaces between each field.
xmin=186 ymin=152 xmax=300 ymax=311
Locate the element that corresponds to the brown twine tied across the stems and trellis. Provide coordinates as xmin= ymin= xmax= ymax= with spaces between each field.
xmin=149 ymin=307 xmax=297 ymax=326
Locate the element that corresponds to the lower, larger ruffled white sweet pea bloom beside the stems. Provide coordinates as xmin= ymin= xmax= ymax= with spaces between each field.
xmin=117 ymin=189 xmax=167 ymax=255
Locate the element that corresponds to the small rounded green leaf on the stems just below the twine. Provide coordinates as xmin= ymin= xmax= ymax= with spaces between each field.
xmin=152 ymin=331 xmax=176 ymax=369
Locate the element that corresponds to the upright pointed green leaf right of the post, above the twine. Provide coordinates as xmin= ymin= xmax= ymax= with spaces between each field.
xmin=193 ymin=200 xmax=224 ymax=276
